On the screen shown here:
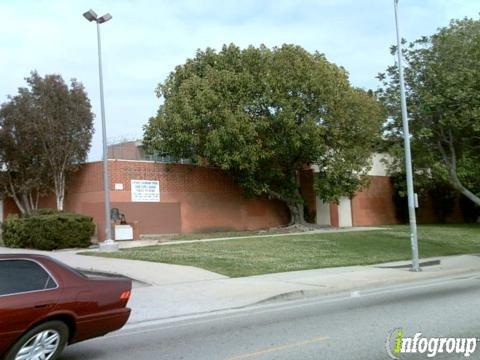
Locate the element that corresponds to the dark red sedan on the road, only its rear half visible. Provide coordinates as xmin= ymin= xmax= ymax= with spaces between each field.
xmin=0 ymin=254 xmax=132 ymax=360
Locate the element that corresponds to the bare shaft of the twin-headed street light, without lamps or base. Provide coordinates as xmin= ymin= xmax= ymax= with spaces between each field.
xmin=96 ymin=21 xmax=113 ymax=245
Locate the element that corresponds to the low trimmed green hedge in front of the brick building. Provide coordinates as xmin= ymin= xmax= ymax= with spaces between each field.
xmin=2 ymin=209 xmax=95 ymax=250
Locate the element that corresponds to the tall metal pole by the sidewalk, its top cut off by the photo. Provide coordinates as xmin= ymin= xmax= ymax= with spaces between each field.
xmin=393 ymin=0 xmax=420 ymax=272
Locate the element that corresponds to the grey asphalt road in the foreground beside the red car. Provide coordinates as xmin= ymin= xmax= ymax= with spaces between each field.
xmin=62 ymin=274 xmax=480 ymax=360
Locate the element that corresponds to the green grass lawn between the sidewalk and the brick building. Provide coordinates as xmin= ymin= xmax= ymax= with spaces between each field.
xmin=88 ymin=225 xmax=480 ymax=277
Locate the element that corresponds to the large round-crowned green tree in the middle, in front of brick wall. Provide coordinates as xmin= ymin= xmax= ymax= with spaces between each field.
xmin=144 ymin=45 xmax=381 ymax=223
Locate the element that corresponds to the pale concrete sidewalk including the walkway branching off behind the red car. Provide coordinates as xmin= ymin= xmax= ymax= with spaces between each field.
xmin=0 ymin=248 xmax=480 ymax=324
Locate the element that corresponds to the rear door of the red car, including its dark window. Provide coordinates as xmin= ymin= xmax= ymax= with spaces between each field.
xmin=0 ymin=258 xmax=60 ymax=354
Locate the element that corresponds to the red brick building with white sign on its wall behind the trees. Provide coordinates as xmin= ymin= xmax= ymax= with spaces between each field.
xmin=0 ymin=142 xmax=460 ymax=240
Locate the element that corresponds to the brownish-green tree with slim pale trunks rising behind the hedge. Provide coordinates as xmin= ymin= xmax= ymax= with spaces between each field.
xmin=0 ymin=72 xmax=94 ymax=213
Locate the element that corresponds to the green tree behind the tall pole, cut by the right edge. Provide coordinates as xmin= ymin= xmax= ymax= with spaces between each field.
xmin=379 ymin=19 xmax=480 ymax=205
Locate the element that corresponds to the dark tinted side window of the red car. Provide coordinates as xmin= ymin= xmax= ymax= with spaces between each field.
xmin=0 ymin=260 xmax=57 ymax=296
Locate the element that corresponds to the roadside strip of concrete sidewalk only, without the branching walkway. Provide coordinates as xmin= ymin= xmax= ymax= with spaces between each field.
xmin=124 ymin=255 xmax=480 ymax=324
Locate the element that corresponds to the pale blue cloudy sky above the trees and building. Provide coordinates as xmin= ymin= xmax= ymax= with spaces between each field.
xmin=0 ymin=0 xmax=480 ymax=161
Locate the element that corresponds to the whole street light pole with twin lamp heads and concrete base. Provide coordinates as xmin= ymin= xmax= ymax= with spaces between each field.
xmin=83 ymin=10 xmax=118 ymax=251
